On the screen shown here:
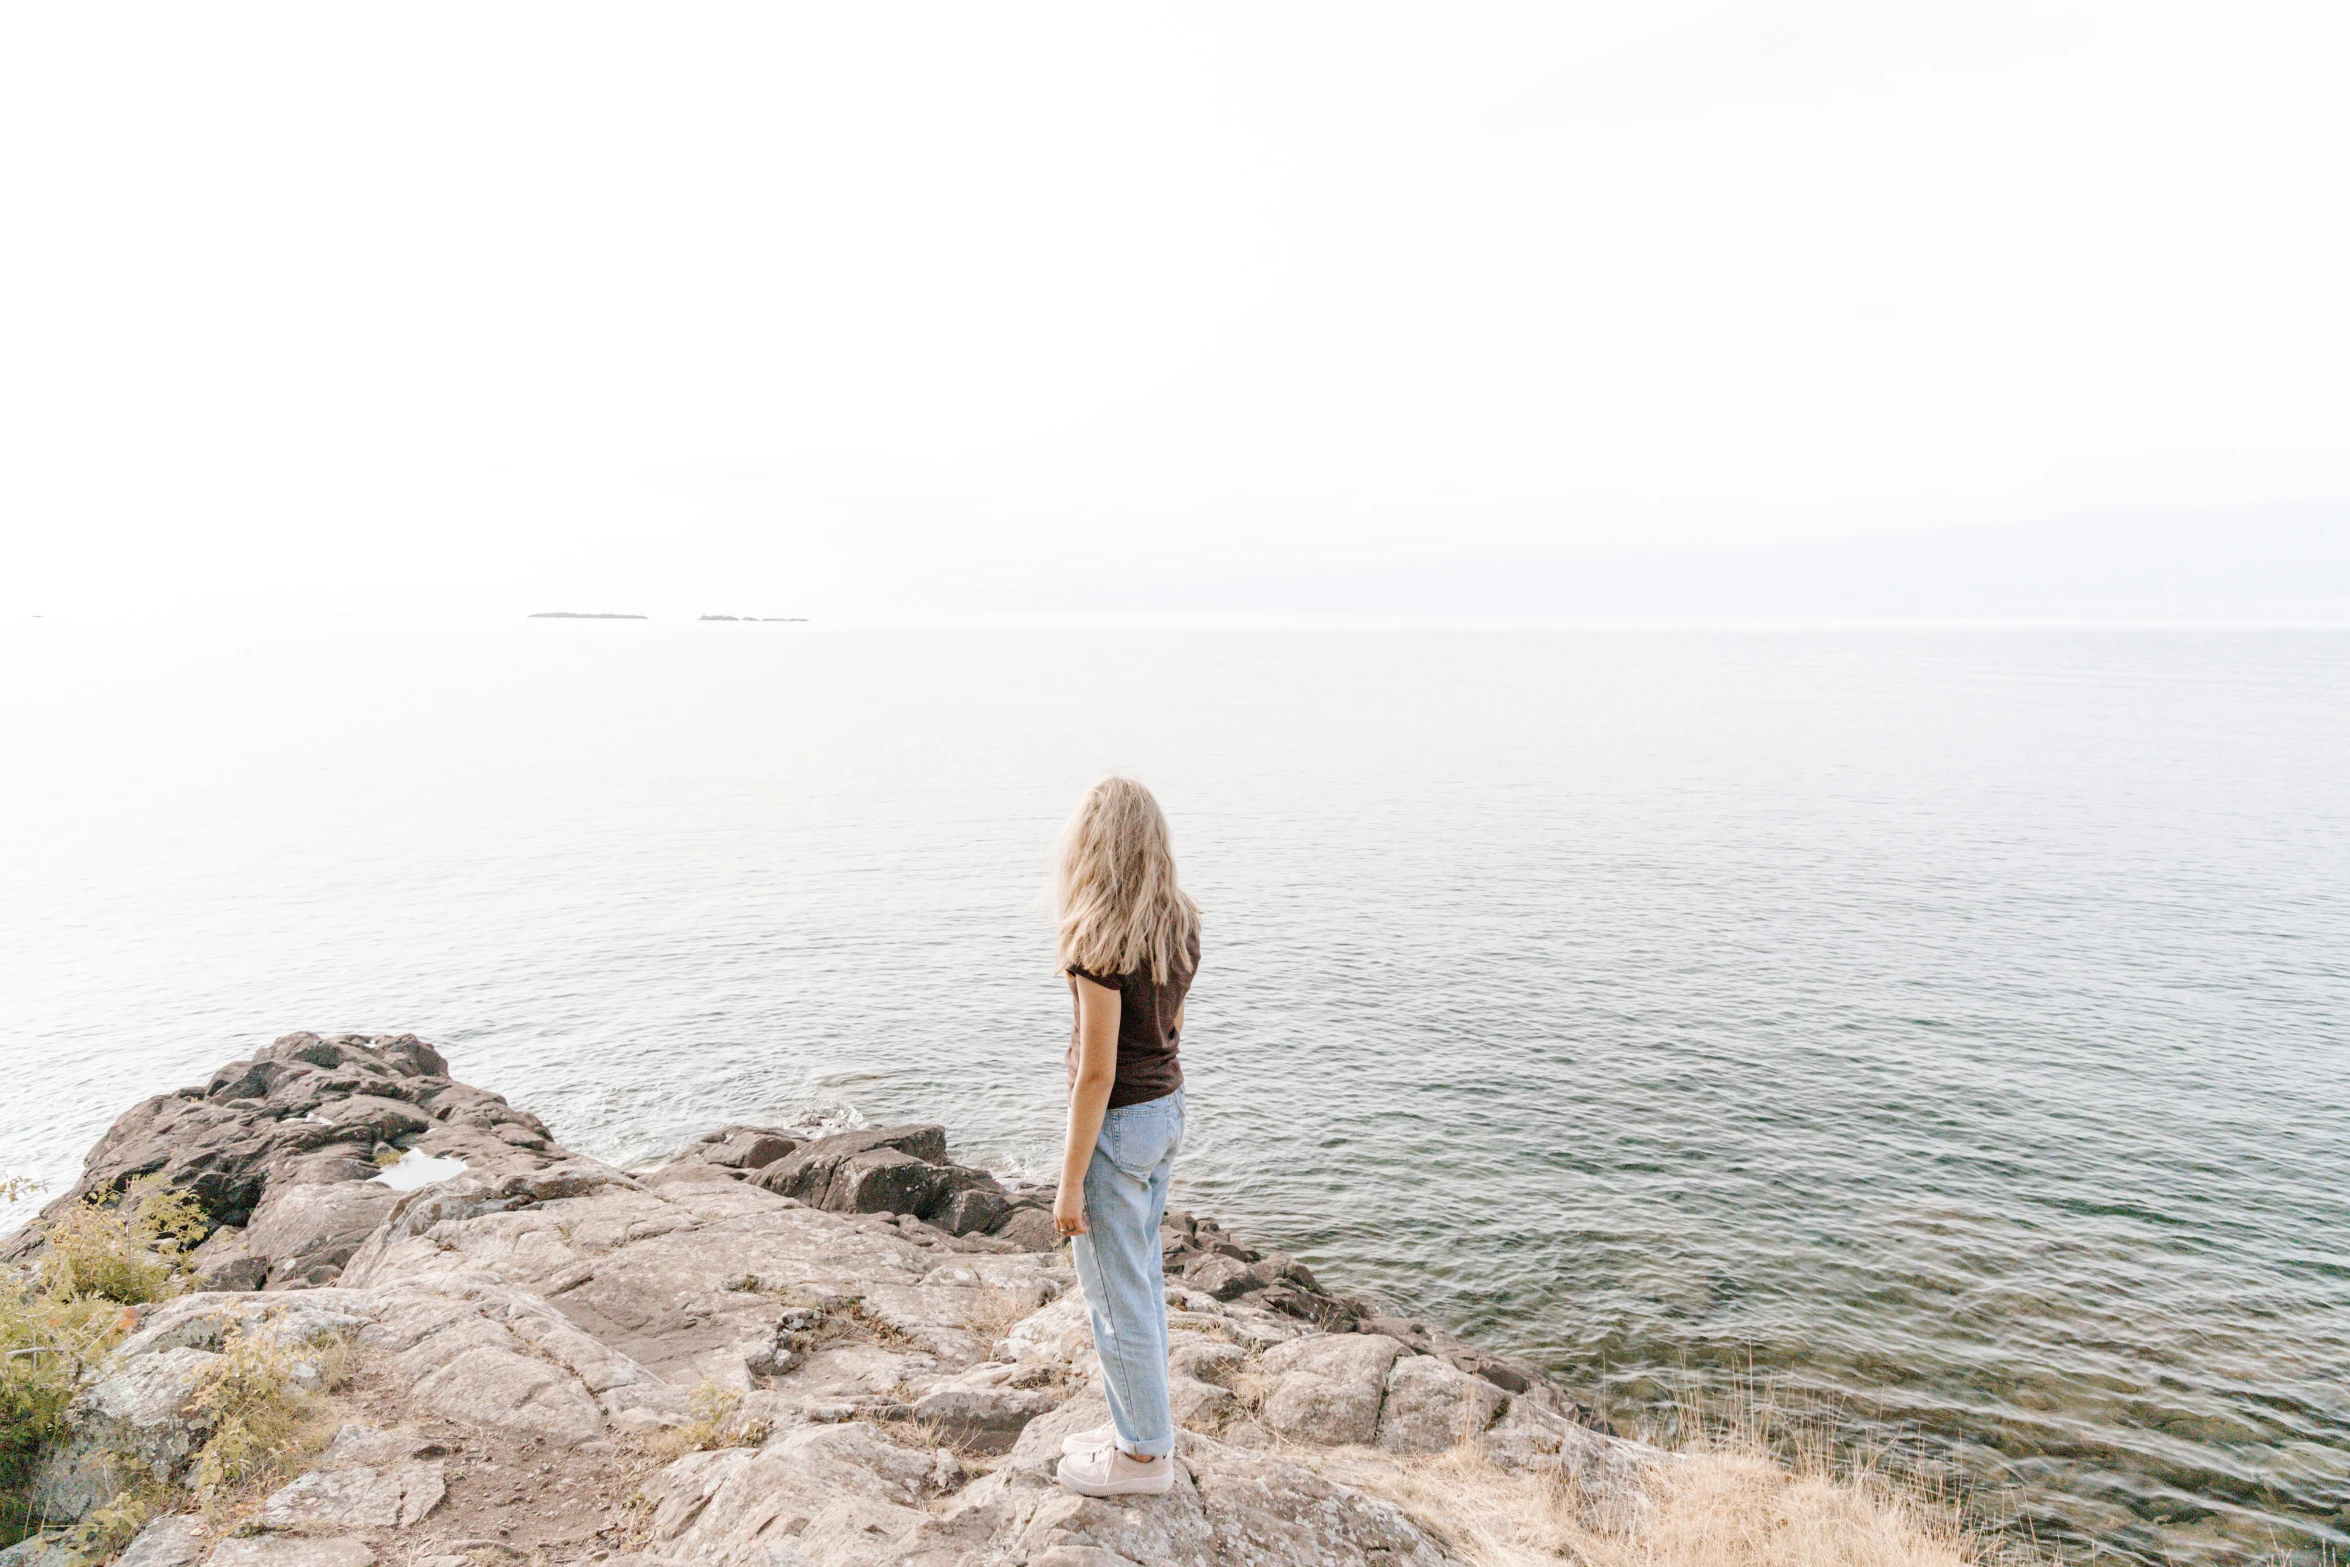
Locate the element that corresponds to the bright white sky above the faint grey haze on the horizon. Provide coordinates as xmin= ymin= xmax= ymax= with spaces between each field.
xmin=0 ymin=0 xmax=2350 ymax=616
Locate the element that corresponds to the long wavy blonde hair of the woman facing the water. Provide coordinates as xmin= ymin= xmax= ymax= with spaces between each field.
xmin=1053 ymin=775 xmax=1199 ymax=984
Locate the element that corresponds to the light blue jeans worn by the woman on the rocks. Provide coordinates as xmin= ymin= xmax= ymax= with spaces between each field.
xmin=1069 ymin=1088 xmax=1182 ymax=1459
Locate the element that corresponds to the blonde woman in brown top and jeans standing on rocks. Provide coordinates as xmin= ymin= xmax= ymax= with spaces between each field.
xmin=1053 ymin=778 xmax=1199 ymax=1497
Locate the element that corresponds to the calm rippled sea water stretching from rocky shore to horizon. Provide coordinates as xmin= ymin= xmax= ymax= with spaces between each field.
xmin=0 ymin=623 xmax=2350 ymax=1562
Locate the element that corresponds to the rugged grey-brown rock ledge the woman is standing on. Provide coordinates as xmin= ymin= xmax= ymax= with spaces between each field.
xmin=0 ymin=1034 xmax=1669 ymax=1567
